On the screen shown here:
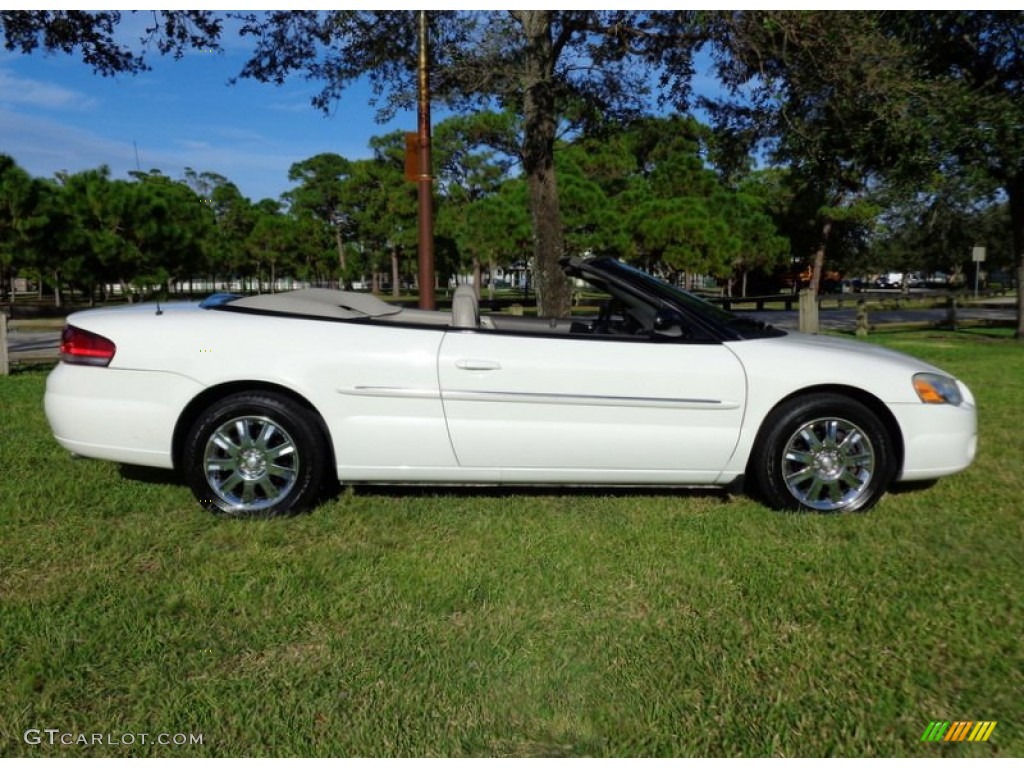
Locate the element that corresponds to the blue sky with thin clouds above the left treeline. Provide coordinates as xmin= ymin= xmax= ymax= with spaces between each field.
xmin=0 ymin=16 xmax=720 ymax=201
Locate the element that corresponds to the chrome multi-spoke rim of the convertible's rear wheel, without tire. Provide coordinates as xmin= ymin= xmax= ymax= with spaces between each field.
xmin=203 ymin=416 xmax=299 ymax=512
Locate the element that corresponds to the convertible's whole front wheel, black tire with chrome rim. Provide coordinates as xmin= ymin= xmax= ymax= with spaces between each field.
xmin=750 ymin=394 xmax=897 ymax=513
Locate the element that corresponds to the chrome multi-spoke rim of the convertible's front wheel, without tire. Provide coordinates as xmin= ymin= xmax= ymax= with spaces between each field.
xmin=782 ymin=418 xmax=876 ymax=512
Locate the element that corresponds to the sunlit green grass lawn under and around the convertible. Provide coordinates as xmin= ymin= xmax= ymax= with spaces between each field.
xmin=0 ymin=331 xmax=1024 ymax=757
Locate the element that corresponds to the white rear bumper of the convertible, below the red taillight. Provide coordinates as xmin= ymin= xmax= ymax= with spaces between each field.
xmin=43 ymin=362 xmax=202 ymax=469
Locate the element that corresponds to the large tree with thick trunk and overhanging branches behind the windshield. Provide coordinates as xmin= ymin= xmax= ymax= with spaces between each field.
xmin=231 ymin=10 xmax=696 ymax=315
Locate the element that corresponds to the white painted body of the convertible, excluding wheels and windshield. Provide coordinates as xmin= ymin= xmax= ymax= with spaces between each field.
xmin=45 ymin=259 xmax=977 ymax=518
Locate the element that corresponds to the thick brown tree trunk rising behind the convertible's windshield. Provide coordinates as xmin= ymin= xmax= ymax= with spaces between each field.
xmin=512 ymin=10 xmax=571 ymax=317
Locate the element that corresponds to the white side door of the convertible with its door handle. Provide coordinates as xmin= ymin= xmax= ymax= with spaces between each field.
xmin=438 ymin=330 xmax=746 ymax=482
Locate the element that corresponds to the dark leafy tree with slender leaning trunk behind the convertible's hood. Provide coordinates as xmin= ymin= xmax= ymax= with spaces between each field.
xmin=711 ymin=11 xmax=934 ymax=291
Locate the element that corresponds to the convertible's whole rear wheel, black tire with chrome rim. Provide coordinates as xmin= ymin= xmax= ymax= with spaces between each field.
xmin=182 ymin=391 xmax=329 ymax=517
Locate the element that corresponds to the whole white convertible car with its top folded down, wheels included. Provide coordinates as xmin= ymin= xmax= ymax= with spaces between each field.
xmin=45 ymin=258 xmax=977 ymax=516
